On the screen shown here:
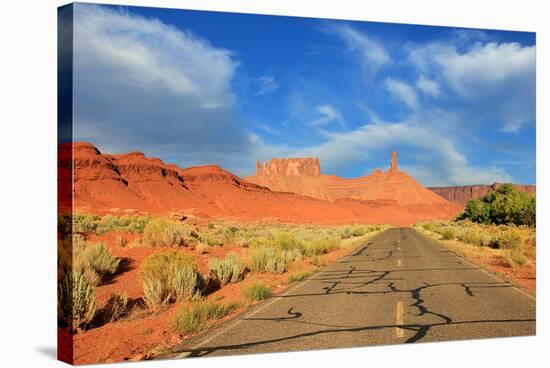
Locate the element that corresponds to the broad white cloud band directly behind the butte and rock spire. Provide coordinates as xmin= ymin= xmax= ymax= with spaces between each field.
xmin=248 ymin=108 xmax=512 ymax=186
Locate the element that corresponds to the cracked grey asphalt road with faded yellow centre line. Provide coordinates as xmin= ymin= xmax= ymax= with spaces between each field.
xmin=167 ymin=228 xmax=536 ymax=357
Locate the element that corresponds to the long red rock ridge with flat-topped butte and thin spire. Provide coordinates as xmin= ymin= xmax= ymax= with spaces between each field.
xmin=58 ymin=142 xmax=461 ymax=225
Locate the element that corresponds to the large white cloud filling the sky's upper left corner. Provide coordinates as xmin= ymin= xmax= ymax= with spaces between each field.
xmin=74 ymin=4 xmax=237 ymax=108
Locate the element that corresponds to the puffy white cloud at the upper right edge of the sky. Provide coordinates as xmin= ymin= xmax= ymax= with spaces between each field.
xmin=408 ymin=42 xmax=536 ymax=132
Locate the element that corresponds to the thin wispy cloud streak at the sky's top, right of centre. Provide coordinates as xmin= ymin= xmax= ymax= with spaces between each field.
xmin=327 ymin=24 xmax=392 ymax=77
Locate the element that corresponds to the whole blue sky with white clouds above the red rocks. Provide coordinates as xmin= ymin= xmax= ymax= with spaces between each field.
xmin=73 ymin=3 xmax=536 ymax=186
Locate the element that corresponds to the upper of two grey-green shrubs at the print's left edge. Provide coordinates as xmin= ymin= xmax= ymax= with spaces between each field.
xmin=73 ymin=242 xmax=120 ymax=285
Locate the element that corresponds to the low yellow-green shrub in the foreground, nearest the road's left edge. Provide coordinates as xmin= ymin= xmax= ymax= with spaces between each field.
xmin=170 ymin=301 xmax=239 ymax=335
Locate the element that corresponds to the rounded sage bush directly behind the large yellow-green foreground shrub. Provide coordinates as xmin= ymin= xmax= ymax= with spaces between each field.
xmin=143 ymin=218 xmax=199 ymax=247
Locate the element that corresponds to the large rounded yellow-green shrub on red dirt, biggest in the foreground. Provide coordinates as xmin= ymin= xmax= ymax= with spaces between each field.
xmin=139 ymin=252 xmax=204 ymax=309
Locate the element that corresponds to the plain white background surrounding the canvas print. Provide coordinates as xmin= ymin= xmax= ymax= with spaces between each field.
xmin=0 ymin=0 xmax=550 ymax=367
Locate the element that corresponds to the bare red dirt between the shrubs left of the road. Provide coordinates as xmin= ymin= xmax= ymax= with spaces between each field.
xmin=74 ymin=232 xmax=366 ymax=364
